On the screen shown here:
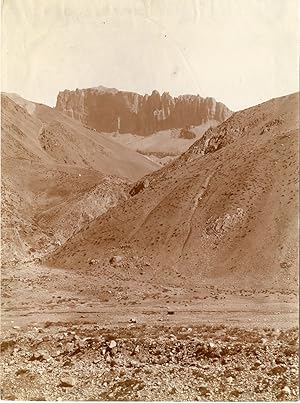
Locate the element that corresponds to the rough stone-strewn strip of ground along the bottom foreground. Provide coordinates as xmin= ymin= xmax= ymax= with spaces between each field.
xmin=1 ymin=322 xmax=298 ymax=401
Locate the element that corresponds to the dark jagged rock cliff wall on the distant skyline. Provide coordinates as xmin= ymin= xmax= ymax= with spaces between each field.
xmin=56 ymin=87 xmax=232 ymax=136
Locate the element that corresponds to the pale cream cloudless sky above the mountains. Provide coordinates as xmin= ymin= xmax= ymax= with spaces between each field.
xmin=2 ymin=0 xmax=300 ymax=110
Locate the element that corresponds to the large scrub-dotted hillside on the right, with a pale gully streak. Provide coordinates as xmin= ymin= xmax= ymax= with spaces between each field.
xmin=51 ymin=94 xmax=299 ymax=289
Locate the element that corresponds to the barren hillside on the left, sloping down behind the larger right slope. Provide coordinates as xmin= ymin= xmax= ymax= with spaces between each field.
xmin=1 ymin=94 xmax=158 ymax=263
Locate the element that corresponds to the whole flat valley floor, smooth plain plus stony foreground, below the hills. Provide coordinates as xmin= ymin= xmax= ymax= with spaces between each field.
xmin=1 ymin=264 xmax=298 ymax=401
